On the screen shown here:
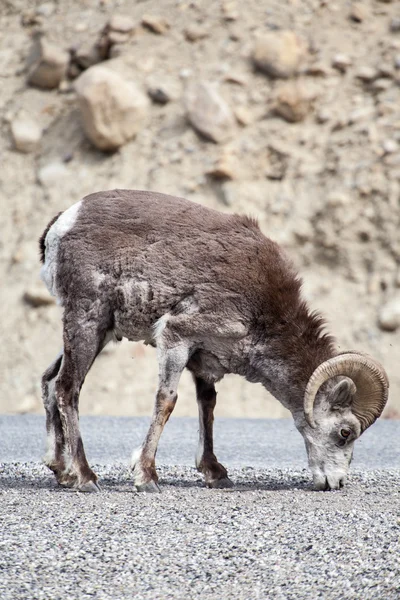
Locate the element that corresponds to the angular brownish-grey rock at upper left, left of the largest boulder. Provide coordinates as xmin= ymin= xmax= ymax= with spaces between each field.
xmin=28 ymin=37 xmax=69 ymax=89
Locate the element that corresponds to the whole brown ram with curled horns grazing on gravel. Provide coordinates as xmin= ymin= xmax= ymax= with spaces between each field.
xmin=40 ymin=190 xmax=389 ymax=491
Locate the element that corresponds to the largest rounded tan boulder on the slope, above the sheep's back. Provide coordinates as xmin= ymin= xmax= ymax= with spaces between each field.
xmin=75 ymin=66 xmax=148 ymax=150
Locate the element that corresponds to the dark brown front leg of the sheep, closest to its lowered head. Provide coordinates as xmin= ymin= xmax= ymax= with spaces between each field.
xmin=194 ymin=377 xmax=233 ymax=488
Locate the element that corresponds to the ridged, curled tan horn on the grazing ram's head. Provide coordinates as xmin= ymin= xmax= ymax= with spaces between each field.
xmin=304 ymin=351 xmax=389 ymax=431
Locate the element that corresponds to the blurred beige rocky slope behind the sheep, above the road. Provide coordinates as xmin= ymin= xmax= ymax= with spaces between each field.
xmin=0 ymin=0 xmax=400 ymax=417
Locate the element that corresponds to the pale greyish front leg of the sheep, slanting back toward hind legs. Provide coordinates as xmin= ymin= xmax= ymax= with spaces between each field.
xmin=132 ymin=344 xmax=189 ymax=492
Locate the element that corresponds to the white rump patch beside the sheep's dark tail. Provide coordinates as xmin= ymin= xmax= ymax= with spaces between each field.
xmin=40 ymin=200 xmax=82 ymax=296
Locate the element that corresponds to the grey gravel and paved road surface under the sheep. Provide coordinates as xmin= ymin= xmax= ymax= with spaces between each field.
xmin=0 ymin=416 xmax=400 ymax=600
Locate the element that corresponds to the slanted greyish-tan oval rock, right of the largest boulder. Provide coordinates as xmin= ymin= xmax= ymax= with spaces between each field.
xmin=185 ymin=81 xmax=235 ymax=143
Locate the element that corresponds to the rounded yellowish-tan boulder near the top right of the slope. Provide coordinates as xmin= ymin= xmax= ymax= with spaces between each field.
xmin=253 ymin=31 xmax=306 ymax=79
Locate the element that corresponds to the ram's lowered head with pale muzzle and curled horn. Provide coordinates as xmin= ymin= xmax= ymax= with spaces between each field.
xmin=295 ymin=352 xmax=389 ymax=490
